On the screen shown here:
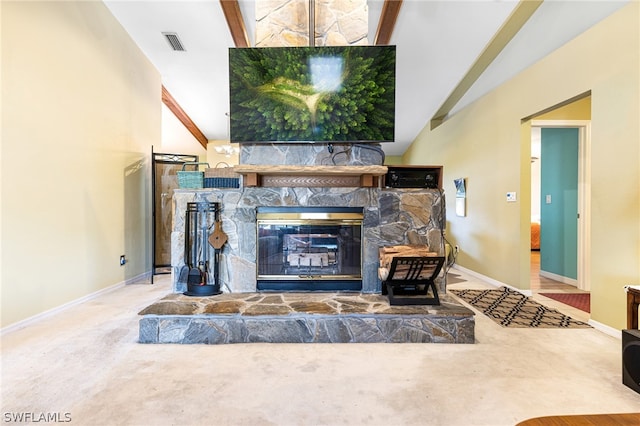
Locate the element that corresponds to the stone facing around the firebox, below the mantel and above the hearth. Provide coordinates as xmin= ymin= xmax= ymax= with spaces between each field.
xmin=172 ymin=188 xmax=445 ymax=293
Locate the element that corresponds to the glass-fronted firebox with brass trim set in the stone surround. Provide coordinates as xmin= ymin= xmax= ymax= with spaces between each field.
xmin=256 ymin=207 xmax=364 ymax=291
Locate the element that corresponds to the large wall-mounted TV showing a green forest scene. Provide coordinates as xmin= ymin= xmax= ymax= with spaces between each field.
xmin=229 ymin=46 xmax=396 ymax=142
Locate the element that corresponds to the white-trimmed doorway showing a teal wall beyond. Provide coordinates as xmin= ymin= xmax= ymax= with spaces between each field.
xmin=531 ymin=120 xmax=590 ymax=291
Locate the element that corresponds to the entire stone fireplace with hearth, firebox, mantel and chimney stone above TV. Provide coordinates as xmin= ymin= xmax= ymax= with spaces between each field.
xmin=139 ymin=0 xmax=475 ymax=344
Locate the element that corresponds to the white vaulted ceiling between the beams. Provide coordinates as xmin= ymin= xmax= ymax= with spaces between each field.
xmin=104 ymin=0 xmax=628 ymax=155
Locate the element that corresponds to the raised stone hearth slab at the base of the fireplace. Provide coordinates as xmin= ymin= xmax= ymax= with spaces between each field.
xmin=139 ymin=292 xmax=475 ymax=344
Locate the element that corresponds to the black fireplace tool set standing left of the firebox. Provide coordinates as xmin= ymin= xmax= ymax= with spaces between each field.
xmin=178 ymin=202 xmax=227 ymax=296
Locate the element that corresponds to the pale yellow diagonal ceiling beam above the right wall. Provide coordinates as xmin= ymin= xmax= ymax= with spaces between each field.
xmin=431 ymin=0 xmax=543 ymax=130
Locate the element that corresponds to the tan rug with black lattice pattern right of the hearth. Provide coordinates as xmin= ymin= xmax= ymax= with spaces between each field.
xmin=449 ymin=287 xmax=591 ymax=328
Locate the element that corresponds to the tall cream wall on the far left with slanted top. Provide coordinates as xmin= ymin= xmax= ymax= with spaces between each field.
xmin=0 ymin=1 xmax=161 ymax=326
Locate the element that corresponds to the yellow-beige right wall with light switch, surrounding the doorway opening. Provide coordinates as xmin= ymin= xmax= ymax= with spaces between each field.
xmin=404 ymin=2 xmax=640 ymax=328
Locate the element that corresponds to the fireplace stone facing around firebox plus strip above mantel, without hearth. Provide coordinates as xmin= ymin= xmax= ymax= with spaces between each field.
xmin=172 ymin=144 xmax=446 ymax=293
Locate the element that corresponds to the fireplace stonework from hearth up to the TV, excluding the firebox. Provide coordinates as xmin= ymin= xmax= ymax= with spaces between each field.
xmin=139 ymin=144 xmax=475 ymax=344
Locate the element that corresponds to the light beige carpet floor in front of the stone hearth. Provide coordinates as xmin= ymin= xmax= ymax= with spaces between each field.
xmin=0 ymin=270 xmax=640 ymax=426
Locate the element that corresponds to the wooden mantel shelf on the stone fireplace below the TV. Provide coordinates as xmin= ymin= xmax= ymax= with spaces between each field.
xmin=233 ymin=164 xmax=387 ymax=188
